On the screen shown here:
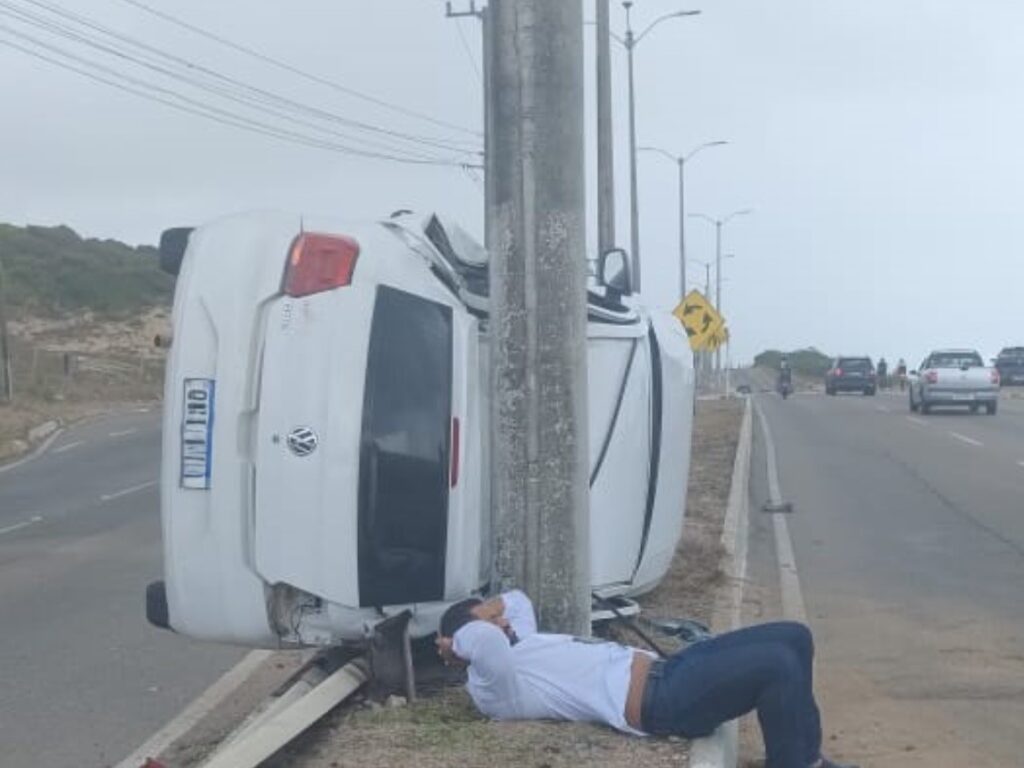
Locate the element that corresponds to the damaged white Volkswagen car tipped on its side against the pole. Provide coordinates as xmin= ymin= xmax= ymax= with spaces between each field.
xmin=146 ymin=213 xmax=693 ymax=647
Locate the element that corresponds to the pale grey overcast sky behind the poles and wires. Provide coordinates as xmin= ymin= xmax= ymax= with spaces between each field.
xmin=0 ymin=0 xmax=1024 ymax=364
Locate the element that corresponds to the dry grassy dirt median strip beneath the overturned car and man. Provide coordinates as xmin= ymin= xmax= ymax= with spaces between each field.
xmin=266 ymin=400 xmax=742 ymax=768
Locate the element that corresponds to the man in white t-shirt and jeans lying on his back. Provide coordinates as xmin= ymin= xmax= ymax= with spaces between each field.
xmin=436 ymin=591 xmax=855 ymax=768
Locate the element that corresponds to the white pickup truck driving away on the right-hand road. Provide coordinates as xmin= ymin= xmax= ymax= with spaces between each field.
xmin=910 ymin=349 xmax=999 ymax=416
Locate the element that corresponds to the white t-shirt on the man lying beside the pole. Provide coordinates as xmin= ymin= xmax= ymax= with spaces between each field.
xmin=454 ymin=591 xmax=643 ymax=735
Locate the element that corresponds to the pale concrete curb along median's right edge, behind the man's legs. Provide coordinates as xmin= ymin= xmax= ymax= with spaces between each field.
xmin=690 ymin=397 xmax=754 ymax=768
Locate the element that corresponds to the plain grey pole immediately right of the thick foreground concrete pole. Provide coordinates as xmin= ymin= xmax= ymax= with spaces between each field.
xmin=595 ymin=0 xmax=614 ymax=253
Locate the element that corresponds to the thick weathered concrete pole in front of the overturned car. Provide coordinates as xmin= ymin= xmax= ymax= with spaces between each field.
xmin=489 ymin=0 xmax=590 ymax=634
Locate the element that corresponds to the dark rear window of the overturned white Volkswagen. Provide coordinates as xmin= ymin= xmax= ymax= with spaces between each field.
xmin=358 ymin=286 xmax=452 ymax=606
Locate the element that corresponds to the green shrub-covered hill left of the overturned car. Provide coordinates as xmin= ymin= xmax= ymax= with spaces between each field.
xmin=0 ymin=224 xmax=174 ymax=318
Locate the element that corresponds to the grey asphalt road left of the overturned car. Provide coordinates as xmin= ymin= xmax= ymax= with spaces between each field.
xmin=0 ymin=412 xmax=245 ymax=768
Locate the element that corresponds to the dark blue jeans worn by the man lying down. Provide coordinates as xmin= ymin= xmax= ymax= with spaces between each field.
xmin=642 ymin=622 xmax=821 ymax=768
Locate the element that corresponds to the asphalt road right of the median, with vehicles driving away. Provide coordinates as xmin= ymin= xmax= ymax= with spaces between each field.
xmin=748 ymin=387 xmax=1024 ymax=768
